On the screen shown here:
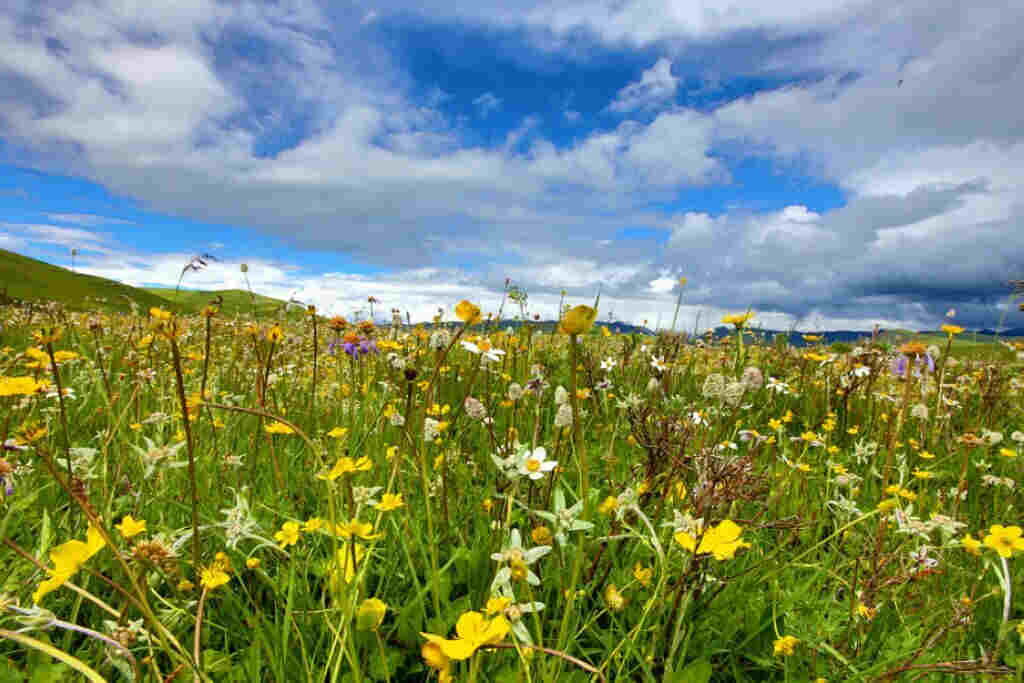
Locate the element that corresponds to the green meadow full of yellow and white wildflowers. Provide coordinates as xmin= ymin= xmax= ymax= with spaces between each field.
xmin=0 ymin=301 xmax=1024 ymax=683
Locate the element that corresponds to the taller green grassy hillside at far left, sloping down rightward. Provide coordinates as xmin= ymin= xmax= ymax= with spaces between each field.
xmin=0 ymin=249 xmax=174 ymax=311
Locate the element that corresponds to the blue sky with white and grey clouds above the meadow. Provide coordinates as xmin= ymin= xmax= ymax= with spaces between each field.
xmin=0 ymin=0 xmax=1024 ymax=331
